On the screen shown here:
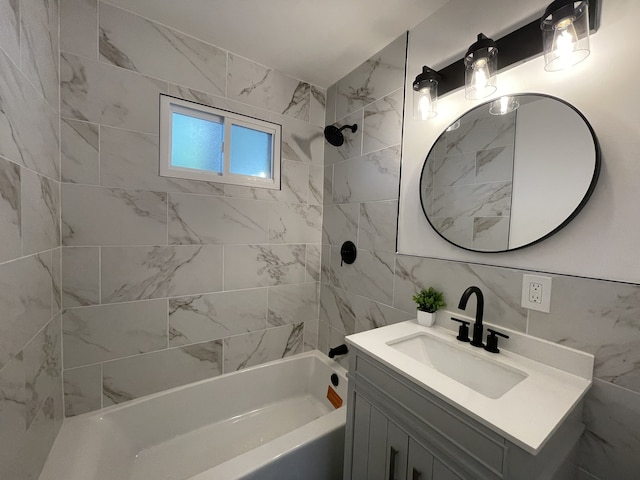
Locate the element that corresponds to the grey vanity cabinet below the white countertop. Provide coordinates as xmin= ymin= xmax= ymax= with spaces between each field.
xmin=344 ymin=347 xmax=583 ymax=480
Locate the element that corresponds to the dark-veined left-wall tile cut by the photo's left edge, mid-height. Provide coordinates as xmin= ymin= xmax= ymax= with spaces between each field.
xmin=0 ymin=158 xmax=22 ymax=262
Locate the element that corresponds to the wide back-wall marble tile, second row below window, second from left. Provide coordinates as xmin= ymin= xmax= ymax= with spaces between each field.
xmin=100 ymin=245 xmax=222 ymax=303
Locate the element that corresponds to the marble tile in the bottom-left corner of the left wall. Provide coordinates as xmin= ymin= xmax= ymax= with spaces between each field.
xmin=0 ymin=352 xmax=27 ymax=479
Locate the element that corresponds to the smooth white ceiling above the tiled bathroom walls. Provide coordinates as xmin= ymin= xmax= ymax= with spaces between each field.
xmin=102 ymin=0 xmax=449 ymax=87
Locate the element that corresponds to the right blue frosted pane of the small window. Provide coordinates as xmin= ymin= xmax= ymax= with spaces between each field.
xmin=229 ymin=125 xmax=273 ymax=178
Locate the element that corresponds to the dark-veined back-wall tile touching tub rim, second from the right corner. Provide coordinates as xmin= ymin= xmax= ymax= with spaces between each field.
xmin=224 ymin=323 xmax=304 ymax=373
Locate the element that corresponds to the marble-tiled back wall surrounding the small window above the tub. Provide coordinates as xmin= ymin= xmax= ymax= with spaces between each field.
xmin=60 ymin=0 xmax=325 ymax=416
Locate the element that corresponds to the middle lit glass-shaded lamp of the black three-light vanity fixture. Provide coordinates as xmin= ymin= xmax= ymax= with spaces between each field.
xmin=464 ymin=33 xmax=498 ymax=100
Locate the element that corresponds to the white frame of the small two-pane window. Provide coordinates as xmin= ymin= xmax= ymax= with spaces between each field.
xmin=160 ymin=94 xmax=282 ymax=190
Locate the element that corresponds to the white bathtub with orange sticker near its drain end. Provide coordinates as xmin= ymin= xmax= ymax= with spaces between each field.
xmin=40 ymin=351 xmax=347 ymax=480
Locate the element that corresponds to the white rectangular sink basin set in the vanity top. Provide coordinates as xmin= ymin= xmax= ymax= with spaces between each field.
xmin=387 ymin=333 xmax=527 ymax=399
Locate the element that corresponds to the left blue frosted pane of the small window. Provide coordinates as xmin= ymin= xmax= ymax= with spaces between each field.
xmin=171 ymin=112 xmax=224 ymax=173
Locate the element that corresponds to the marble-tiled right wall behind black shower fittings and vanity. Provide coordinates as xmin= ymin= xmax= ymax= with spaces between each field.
xmin=318 ymin=34 xmax=640 ymax=480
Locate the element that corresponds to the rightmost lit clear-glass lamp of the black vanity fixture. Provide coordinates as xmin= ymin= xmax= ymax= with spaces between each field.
xmin=540 ymin=0 xmax=589 ymax=72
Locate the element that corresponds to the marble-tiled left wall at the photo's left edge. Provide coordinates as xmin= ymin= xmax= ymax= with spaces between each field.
xmin=0 ymin=0 xmax=62 ymax=480
